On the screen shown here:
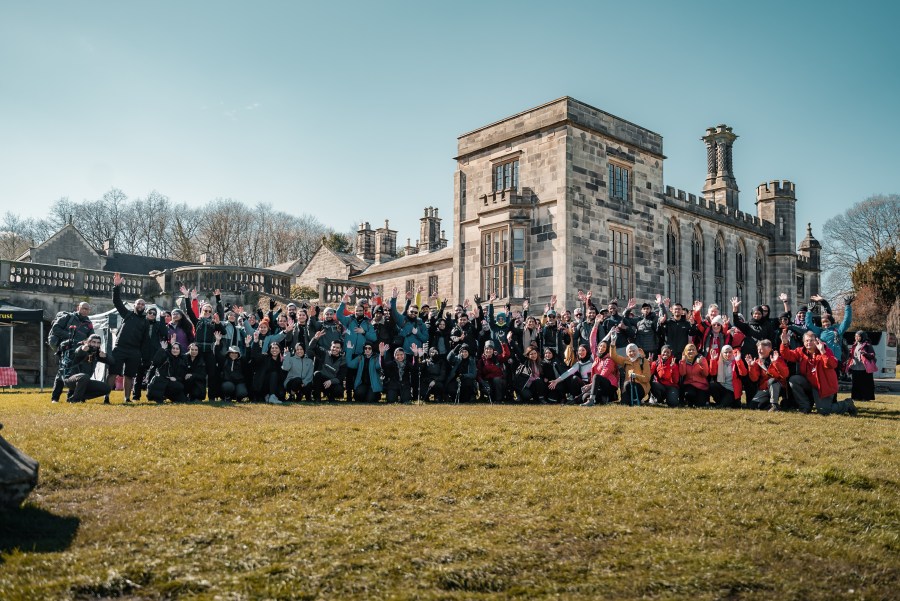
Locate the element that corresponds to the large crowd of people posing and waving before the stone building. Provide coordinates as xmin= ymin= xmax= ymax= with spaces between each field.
xmin=51 ymin=274 xmax=875 ymax=415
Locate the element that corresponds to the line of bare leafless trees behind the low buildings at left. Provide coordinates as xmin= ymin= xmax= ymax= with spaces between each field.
xmin=0 ymin=188 xmax=352 ymax=267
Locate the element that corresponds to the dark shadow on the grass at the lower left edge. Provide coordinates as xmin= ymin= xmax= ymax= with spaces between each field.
xmin=0 ymin=505 xmax=81 ymax=563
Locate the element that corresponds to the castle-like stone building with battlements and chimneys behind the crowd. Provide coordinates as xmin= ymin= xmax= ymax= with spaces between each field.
xmin=301 ymin=97 xmax=821 ymax=312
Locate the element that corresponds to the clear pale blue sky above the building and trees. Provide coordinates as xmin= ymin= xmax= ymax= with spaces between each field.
xmin=0 ymin=1 xmax=900 ymax=242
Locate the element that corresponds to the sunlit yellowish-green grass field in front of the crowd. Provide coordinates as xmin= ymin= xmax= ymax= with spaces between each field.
xmin=0 ymin=393 xmax=900 ymax=601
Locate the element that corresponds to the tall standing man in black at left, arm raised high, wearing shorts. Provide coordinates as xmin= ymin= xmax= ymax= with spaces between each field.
xmin=104 ymin=272 xmax=147 ymax=403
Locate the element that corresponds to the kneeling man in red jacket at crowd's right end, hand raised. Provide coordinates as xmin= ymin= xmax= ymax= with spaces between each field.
xmin=781 ymin=330 xmax=857 ymax=415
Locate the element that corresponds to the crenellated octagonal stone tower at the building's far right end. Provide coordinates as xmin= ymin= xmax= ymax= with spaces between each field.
xmin=756 ymin=180 xmax=797 ymax=304
